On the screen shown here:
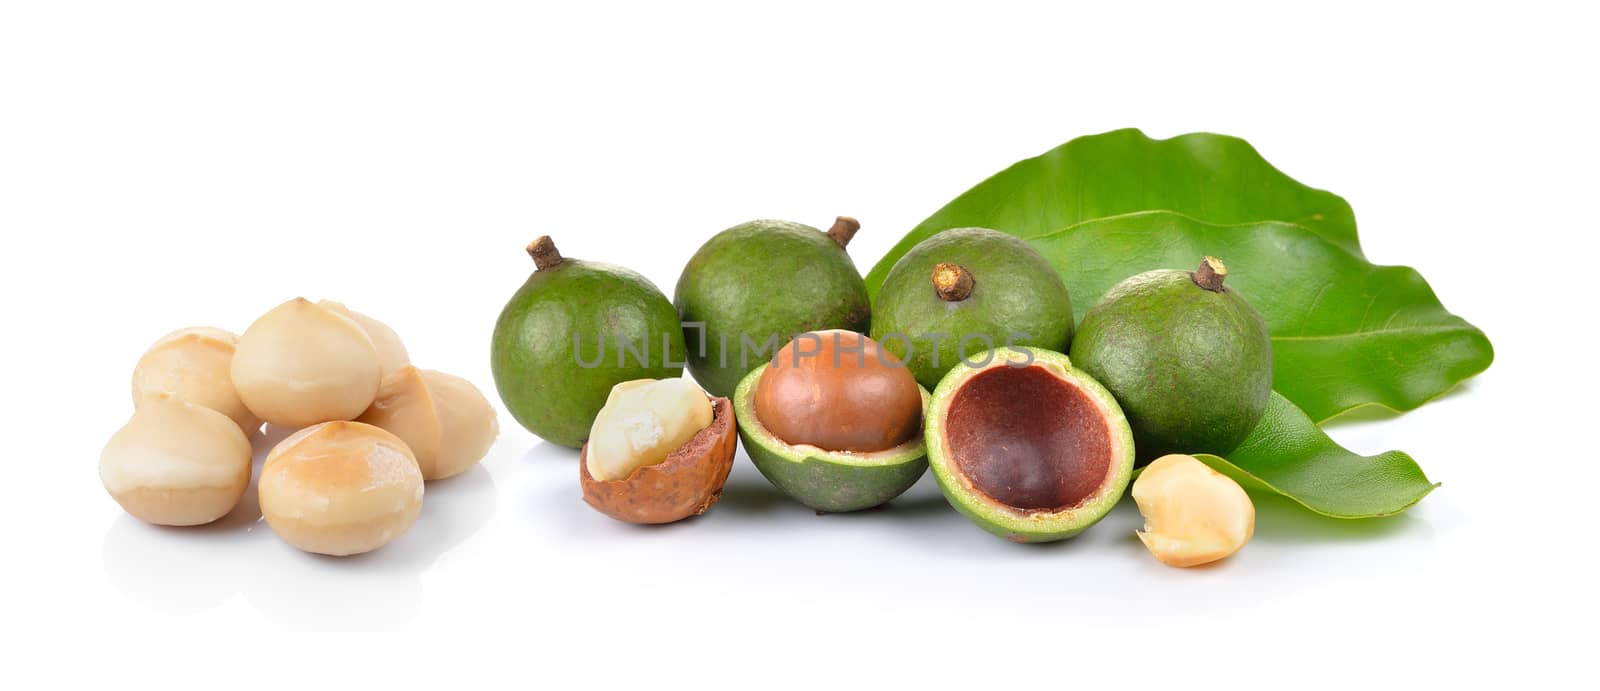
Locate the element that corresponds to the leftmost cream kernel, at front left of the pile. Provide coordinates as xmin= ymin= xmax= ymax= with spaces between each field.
xmin=99 ymin=393 xmax=250 ymax=526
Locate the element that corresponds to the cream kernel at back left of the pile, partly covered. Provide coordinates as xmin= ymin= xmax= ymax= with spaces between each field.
xmin=133 ymin=326 xmax=261 ymax=437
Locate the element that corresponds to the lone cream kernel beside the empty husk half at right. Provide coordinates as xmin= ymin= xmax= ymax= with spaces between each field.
xmin=1133 ymin=454 xmax=1256 ymax=566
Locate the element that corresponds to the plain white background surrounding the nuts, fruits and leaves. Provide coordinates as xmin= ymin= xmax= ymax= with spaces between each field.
xmin=0 ymin=2 xmax=1600 ymax=688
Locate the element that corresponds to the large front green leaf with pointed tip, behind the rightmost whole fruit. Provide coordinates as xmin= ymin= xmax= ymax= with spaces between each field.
xmin=1027 ymin=211 xmax=1494 ymax=421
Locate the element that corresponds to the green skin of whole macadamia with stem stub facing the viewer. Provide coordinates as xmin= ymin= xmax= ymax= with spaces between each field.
xmin=872 ymin=229 xmax=1072 ymax=389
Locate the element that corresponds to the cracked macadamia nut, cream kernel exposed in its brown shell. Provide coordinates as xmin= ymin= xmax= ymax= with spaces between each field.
xmin=578 ymin=379 xmax=738 ymax=523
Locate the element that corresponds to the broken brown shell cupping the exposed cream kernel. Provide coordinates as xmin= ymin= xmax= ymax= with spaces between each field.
xmin=578 ymin=398 xmax=739 ymax=525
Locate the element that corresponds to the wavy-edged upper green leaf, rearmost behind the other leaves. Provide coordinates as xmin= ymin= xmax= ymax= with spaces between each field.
xmin=867 ymin=130 xmax=1362 ymax=302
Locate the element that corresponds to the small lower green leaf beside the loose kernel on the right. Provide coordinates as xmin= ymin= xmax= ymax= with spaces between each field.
xmin=1195 ymin=393 xmax=1438 ymax=518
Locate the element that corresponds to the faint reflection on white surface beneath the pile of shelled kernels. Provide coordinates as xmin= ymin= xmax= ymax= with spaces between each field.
xmin=102 ymin=427 xmax=498 ymax=630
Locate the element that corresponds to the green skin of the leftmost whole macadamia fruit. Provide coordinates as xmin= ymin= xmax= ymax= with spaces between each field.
xmin=491 ymin=259 xmax=686 ymax=448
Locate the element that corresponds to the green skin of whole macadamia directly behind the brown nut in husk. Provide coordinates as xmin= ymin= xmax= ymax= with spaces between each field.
xmin=674 ymin=221 xmax=872 ymax=397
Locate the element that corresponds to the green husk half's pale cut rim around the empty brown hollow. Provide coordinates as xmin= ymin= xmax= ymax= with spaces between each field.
xmin=923 ymin=349 xmax=1134 ymax=544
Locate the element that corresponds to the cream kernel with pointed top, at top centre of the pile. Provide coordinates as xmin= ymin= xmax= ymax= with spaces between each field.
xmin=232 ymin=298 xmax=382 ymax=427
